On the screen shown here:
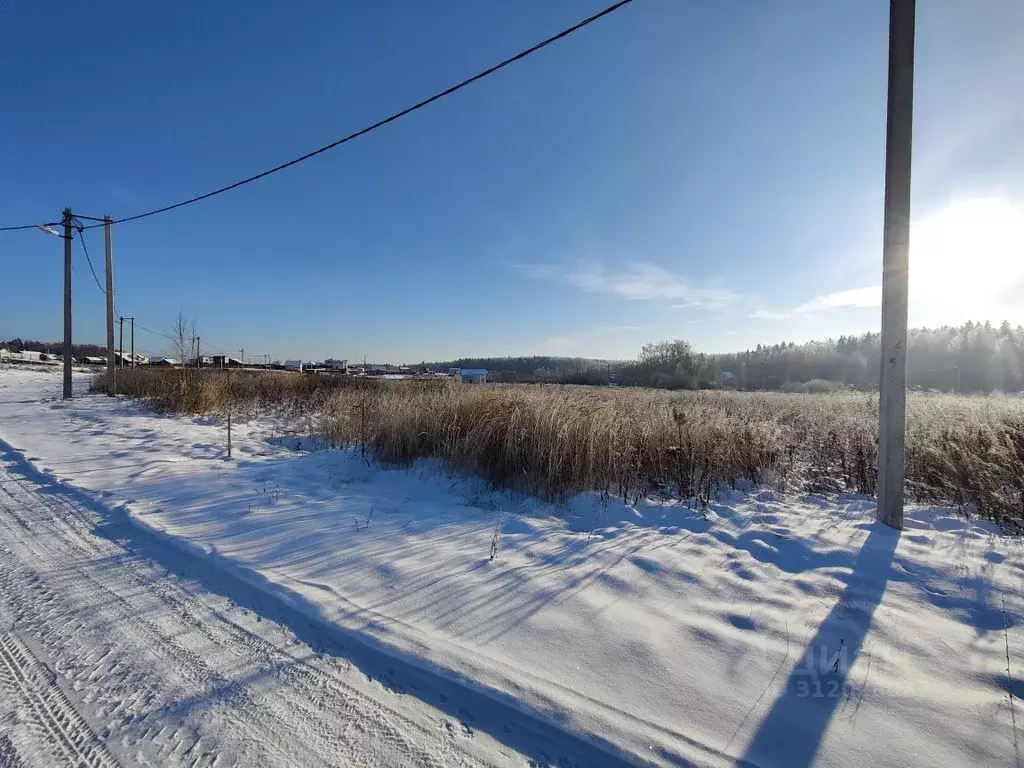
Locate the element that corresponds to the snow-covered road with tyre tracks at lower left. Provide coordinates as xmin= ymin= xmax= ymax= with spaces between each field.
xmin=0 ymin=444 xmax=603 ymax=768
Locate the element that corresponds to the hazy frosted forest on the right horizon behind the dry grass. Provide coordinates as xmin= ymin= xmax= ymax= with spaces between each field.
xmin=425 ymin=323 xmax=1024 ymax=393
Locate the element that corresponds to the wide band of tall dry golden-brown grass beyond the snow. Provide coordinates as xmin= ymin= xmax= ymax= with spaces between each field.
xmin=99 ymin=370 xmax=1024 ymax=525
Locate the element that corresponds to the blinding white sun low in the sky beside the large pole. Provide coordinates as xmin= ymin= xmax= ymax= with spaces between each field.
xmin=909 ymin=198 xmax=1024 ymax=325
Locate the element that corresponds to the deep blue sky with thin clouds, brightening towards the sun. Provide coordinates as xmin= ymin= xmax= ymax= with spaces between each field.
xmin=0 ymin=0 xmax=1024 ymax=361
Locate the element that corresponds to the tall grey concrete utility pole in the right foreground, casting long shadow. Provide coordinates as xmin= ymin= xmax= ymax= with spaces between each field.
xmin=878 ymin=0 xmax=914 ymax=528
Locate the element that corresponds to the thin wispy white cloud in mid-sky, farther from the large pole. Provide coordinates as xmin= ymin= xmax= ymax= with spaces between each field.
xmin=517 ymin=261 xmax=739 ymax=309
